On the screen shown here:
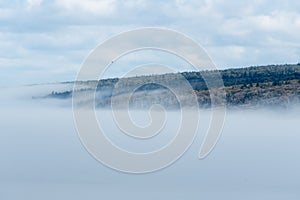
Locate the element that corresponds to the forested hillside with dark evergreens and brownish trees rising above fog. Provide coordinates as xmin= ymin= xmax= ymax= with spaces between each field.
xmin=43 ymin=64 xmax=300 ymax=108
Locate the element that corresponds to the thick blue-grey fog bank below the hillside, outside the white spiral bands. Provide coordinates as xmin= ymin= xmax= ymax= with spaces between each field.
xmin=0 ymin=84 xmax=300 ymax=200
